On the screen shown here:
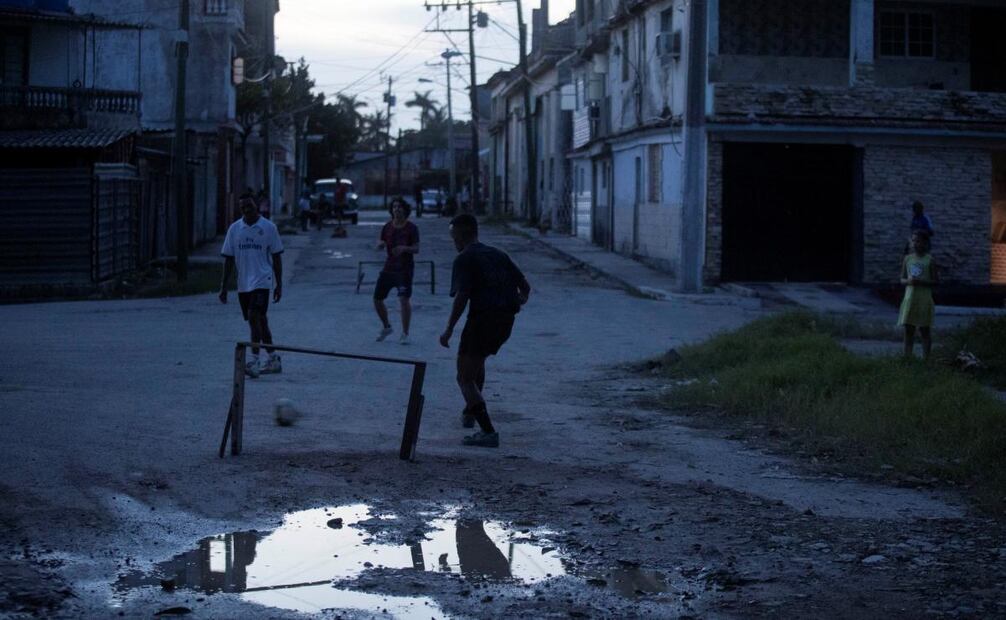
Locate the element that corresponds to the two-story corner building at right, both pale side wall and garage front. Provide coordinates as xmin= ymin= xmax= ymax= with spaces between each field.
xmin=497 ymin=0 xmax=1006 ymax=288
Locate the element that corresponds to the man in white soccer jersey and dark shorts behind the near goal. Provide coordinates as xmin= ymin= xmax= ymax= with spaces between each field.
xmin=220 ymin=198 xmax=283 ymax=378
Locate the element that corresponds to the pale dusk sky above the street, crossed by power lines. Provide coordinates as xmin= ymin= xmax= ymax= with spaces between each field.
xmin=276 ymin=0 xmax=575 ymax=132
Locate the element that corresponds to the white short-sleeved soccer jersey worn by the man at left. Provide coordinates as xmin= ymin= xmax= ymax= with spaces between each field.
xmin=220 ymin=217 xmax=283 ymax=293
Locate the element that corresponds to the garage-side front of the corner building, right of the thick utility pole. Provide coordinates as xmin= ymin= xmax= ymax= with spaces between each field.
xmin=703 ymin=0 xmax=1006 ymax=286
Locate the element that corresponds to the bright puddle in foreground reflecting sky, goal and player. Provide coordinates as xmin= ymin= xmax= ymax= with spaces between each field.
xmin=116 ymin=504 xmax=565 ymax=618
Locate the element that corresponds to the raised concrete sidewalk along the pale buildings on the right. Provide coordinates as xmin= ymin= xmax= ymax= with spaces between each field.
xmin=504 ymin=221 xmax=762 ymax=309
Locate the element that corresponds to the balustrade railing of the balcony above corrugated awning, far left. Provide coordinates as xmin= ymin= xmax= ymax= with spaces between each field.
xmin=0 ymin=85 xmax=140 ymax=114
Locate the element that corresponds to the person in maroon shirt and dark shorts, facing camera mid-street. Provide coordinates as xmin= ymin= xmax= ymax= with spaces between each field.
xmin=374 ymin=197 xmax=420 ymax=344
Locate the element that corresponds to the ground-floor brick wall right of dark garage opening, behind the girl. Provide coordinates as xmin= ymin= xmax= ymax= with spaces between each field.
xmin=863 ymin=146 xmax=992 ymax=285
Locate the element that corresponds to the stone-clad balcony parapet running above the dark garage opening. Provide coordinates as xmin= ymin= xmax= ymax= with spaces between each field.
xmin=713 ymin=84 xmax=1006 ymax=127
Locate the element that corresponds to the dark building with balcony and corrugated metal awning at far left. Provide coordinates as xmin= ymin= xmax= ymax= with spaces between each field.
xmin=0 ymin=0 xmax=142 ymax=289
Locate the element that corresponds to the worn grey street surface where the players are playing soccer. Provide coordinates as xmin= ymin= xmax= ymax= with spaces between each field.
xmin=0 ymin=214 xmax=1006 ymax=618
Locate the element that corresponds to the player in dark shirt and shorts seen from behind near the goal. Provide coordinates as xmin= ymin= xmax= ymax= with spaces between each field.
xmin=440 ymin=213 xmax=531 ymax=448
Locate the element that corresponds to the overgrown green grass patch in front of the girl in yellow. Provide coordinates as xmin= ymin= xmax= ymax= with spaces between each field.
xmin=663 ymin=312 xmax=1006 ymax=506
